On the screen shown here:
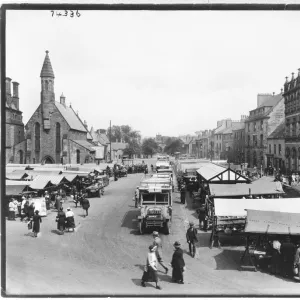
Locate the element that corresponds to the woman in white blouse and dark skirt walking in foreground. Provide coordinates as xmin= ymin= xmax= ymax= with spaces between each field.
xmin=141 ymin=245 xmax=161 ymax=290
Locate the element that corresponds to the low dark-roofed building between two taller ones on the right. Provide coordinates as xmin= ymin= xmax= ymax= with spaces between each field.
xmin=266 ymin=120 xmax=286 ymax=173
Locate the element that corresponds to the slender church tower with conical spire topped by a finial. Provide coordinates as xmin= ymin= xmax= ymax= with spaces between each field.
xmin=41 ymin=51 xmax=55 ymax=130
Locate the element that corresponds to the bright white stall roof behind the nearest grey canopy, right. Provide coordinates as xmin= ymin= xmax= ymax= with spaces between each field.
xmin=214 ymin=198 xmax=300 ymax=217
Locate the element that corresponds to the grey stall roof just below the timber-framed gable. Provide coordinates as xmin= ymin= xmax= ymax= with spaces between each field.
xmin=209 ymin=181 xmax=284 ymax=197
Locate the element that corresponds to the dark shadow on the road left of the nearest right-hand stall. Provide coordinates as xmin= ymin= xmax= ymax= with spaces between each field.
xmin=214 ymin=250 xmax=243 ymax=270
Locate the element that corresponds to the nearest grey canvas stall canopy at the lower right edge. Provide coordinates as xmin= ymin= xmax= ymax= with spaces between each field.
xmin=245 ymin=209 xmax=300 ymax=235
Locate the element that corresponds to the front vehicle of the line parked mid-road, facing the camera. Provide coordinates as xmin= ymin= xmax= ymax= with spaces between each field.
xmin=138 ymin=177 xmax=172 ymax=234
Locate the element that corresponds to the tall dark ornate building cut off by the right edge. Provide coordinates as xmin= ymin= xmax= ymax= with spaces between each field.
xmin=283 ymin=69 xmax=300 ymax=171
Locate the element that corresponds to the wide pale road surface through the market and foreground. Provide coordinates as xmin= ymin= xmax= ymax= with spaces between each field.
xmin=6 ymin=162 xmax=300 ymax=296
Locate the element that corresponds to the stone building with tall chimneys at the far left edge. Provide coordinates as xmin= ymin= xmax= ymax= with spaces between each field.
xmin=5 ymin=77 xmax=26 ymax=164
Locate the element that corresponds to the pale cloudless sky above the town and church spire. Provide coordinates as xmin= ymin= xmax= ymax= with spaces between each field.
xmin=6 ymin=10 xmax=300 ymax=137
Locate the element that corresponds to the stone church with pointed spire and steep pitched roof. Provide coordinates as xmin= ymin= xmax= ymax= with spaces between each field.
xmin=25 ymin=51 xmax=95 ymax=164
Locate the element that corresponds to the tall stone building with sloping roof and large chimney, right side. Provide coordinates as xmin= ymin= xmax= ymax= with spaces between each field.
xmin=245 ymin=93 xmax=284 ymax=170
